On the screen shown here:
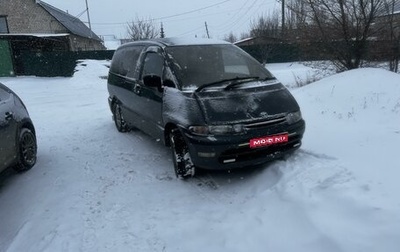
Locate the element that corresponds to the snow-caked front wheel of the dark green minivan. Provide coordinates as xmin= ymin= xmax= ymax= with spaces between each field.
xmin=169 ymin=130 xmax=196 ymax=179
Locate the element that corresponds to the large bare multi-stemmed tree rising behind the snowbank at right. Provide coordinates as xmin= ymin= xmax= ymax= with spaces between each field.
xmin=299 ymin=0 xmax=385 ymax=70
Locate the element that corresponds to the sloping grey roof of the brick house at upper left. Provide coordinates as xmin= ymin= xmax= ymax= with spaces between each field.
xmin=38 ymin=1 xmax=101 ymax=41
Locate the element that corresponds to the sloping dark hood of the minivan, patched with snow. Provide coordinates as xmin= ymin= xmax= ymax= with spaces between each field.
xmin=194 ymin=83 xmax=299 ymax=124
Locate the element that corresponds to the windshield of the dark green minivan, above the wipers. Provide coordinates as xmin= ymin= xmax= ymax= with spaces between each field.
xmin=166 ymin=44 xmax=274 ymax=89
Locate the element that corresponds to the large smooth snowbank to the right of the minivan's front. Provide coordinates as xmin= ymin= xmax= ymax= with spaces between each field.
xmin=294 ymin=68 xmax=400 ymax=204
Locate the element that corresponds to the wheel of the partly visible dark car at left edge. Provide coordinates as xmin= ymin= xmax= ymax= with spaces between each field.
xmin=14 ymin=128 xmax=37 ymax=172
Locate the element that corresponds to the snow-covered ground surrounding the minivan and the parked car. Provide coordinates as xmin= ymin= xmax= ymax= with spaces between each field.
xmin=0 ymin=61 xmax=400 ymax=252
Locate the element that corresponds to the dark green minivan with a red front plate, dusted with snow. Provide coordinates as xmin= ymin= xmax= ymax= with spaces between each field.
xmin=108 ymin=38 xmax=305 ymax=178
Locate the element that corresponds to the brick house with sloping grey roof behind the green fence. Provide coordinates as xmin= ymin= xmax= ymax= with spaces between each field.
xmin=0 ymin=0 xmax=105 ymax=51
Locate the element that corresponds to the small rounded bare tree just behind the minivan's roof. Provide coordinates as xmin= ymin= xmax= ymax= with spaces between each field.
xmin=127 ymin=17 xmax=160 ymax=41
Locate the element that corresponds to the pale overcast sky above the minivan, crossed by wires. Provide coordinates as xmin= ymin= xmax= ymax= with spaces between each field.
xmin=44 ymin=0 xmax=280 ymax=39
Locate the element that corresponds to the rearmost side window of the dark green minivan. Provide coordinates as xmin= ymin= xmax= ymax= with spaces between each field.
xmin=110 ymin=46 xmax=144 ymax=78
